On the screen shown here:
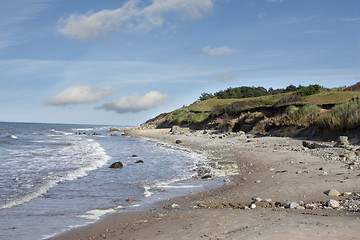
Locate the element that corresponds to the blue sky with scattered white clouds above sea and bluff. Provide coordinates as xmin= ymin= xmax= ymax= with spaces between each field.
xmin=0 ymin=0 xmax=360 ymax=125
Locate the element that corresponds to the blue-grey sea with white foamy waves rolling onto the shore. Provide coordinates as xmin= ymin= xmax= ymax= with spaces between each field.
xmin=0 ymin=122 xmax=221 ymax=240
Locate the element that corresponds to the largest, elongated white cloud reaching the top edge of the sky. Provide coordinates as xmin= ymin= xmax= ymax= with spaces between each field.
xmin=57 ymin=0 xmax=214 ymax=39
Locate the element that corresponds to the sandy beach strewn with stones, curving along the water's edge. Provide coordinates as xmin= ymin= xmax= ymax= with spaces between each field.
xmin=51 ymin=129 xmax=360 ymax=240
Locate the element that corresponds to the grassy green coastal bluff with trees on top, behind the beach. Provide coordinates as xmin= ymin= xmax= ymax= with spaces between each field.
xmin=146 ymin=85 xmax=360 ymax=132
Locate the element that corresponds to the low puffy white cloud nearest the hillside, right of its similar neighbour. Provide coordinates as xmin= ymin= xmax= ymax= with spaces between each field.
xmin=97 ymin=91 xmax=168 ymax=113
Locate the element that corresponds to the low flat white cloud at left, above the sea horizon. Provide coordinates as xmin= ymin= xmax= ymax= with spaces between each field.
xmin=45 ymin=85 xmax=116 ymax=105
